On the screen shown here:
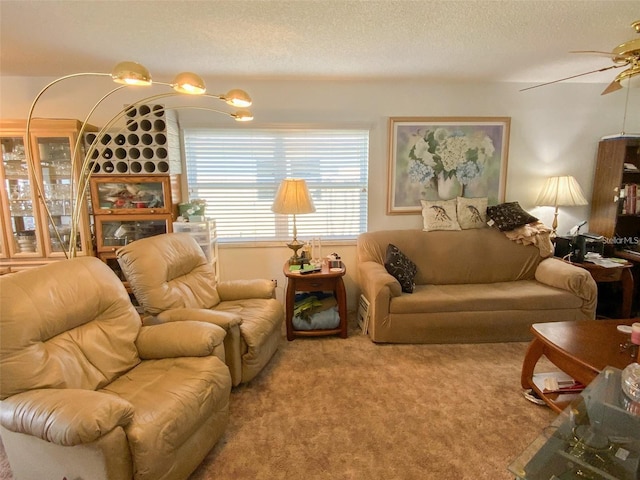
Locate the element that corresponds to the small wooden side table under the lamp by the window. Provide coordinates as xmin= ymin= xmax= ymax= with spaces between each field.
xmin=282 ymin=262 xmax=347 ymax=340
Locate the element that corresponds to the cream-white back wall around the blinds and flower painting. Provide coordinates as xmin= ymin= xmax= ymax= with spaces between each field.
xmin=0 ymin=77 xmax=640 ymax=308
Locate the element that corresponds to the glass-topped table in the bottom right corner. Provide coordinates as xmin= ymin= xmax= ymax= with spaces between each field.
xmin=509 ymin=367 xmax=640 ymax=480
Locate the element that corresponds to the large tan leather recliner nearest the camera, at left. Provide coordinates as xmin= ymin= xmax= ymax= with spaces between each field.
xmin=0 ymin=257 xmax=231 ymax=480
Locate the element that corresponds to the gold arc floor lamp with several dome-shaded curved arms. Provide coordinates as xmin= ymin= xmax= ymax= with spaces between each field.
xmin=25 ymin=62 xmax=253 ymax=257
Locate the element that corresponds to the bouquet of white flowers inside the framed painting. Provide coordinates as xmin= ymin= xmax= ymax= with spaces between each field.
xmin=407 ymin=127 xmax=495 ymax=185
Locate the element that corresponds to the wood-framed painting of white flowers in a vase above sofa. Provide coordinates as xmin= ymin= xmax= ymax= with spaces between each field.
xmin=388 ymin=117 xmax=510 ymax=213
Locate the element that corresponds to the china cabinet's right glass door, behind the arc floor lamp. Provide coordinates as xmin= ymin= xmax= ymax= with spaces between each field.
xmin=37 ymin=137 xmax=82 ymax=256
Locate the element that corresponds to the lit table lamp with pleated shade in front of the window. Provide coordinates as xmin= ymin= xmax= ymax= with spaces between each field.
xmin=271 ymin=178 xmax=316 ymax=265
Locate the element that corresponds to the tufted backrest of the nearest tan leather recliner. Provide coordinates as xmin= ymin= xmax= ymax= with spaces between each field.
xmin=0 ymin=257 xmax=141 ymax=399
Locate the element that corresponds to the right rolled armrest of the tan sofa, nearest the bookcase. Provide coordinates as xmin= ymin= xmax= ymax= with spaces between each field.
xmin=535 ymin=258 xmax=598 ymax=319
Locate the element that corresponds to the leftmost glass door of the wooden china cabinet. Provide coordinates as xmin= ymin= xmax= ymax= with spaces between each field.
xmin=0 ymin=137 xmax=41 ymax=257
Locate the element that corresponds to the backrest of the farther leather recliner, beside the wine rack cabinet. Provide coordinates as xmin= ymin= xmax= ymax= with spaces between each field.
xmin=116 ymin=233 xmax=220 ymax=315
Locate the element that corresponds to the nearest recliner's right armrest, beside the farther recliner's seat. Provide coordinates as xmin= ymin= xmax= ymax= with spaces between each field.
xmin=136 ymin=320 xmax=226 ymax=360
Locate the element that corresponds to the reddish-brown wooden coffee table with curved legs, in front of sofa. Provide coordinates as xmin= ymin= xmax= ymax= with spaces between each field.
xmin=520 ymin=319 xmax=640 ymax=413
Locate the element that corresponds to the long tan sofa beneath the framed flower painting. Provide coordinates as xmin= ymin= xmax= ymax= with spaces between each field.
xmin=357 ymin=228 xmax=597 ymax=343
